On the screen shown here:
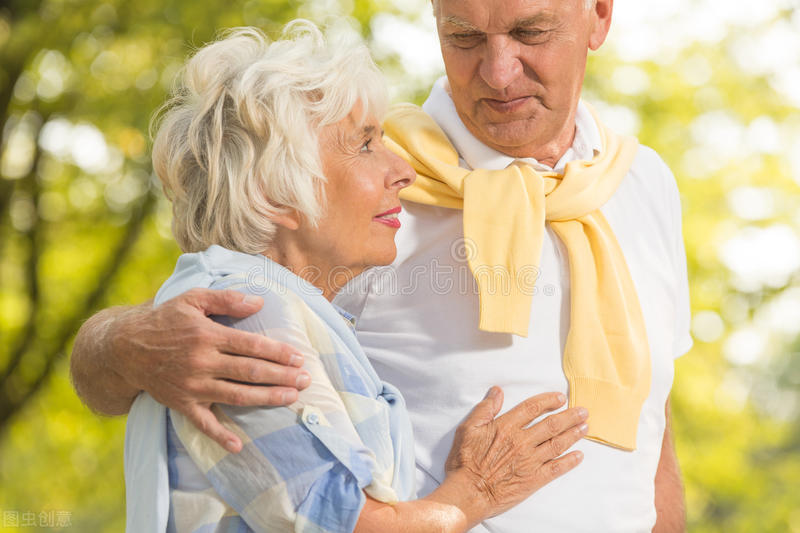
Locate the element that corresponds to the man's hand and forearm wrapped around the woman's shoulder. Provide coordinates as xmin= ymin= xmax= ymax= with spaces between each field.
xmin=71 ymin=289 xmax=310 ymax=452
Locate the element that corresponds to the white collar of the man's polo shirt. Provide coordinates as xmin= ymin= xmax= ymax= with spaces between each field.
xmin=422 ymin=76 xmax=602 ymax=172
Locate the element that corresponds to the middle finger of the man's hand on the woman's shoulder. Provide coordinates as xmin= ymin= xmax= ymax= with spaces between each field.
xmin=211 ymin=355 xmax=311 ymax=390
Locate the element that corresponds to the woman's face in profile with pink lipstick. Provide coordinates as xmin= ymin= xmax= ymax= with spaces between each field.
xmin=300 ymin=105 xmax=416 ymax=288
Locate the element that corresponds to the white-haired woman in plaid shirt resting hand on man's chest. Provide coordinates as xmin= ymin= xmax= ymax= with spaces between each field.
xmin=126 ymin=21 xmax=583 ymax=533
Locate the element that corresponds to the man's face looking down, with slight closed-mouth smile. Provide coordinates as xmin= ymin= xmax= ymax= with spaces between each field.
xmin=434 ymin=0 xmax=613 ymax=164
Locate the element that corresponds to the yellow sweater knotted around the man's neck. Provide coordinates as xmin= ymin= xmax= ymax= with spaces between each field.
xmin=383 ymin=104 xmax=650 ymax=450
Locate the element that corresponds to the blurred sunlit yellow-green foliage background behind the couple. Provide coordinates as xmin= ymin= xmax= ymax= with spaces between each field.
xmin=0 ymin=0 xmax=800 ymax=533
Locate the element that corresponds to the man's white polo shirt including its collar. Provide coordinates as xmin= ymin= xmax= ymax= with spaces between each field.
xmin=335 ymin=78 xmax=692 ymax=533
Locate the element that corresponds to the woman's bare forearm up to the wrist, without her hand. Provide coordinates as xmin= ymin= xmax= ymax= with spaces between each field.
xmin=355 ymin=473 xmax=490 ymax=533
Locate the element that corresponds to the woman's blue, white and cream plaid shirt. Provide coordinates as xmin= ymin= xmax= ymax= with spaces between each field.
xmin=128 ymin=246 xmax=415 ymax=532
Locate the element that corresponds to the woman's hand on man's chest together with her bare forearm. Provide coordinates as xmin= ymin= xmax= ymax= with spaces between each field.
xmin=356 ymin=387 xmax=588 ymax=533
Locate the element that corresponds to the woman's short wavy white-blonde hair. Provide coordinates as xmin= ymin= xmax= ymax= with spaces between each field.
xmin=153 ymin=20 xmax=388 ymax=254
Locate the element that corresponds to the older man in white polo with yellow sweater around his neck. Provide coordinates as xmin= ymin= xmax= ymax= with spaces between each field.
xmin=72 ymin=0 xmax=691 ymax=532
